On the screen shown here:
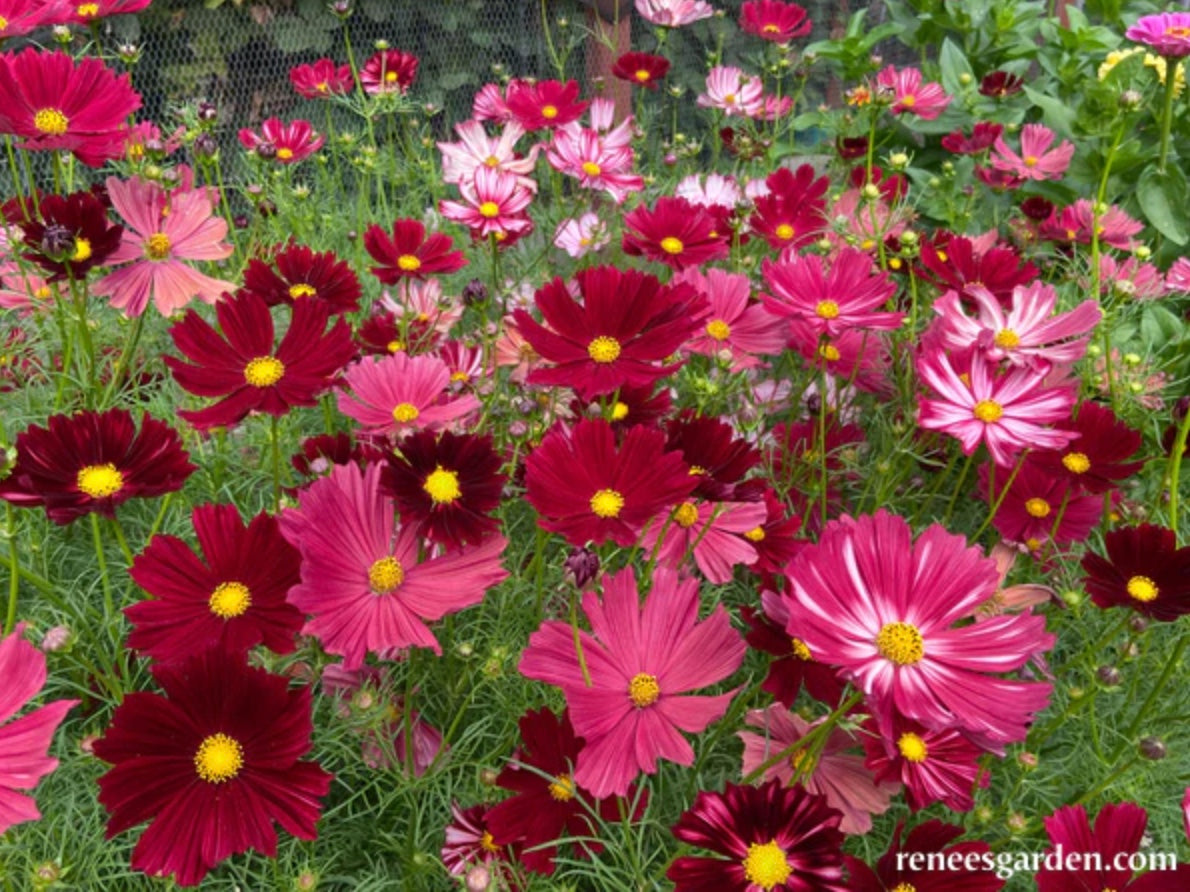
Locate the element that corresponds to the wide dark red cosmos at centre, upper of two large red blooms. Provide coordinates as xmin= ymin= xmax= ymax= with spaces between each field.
xmin=513 ymin=266 xmax=707 ymax=400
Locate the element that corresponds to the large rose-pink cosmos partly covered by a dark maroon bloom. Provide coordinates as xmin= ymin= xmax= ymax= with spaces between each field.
xmin=280 ymin=464 xmax=508 ymax=668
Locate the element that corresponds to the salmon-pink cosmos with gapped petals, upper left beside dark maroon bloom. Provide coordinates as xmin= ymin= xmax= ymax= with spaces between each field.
xmin=92 ymin=176 xmax=236 ymax=316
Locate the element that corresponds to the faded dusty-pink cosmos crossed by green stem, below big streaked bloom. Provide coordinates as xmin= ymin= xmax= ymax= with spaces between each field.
xmin=735 ymin=703 xmax=901 ymax=834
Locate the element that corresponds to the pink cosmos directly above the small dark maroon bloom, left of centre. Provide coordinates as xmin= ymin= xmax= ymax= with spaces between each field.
xmin=337 ymin=352 xmax=480 ymax=434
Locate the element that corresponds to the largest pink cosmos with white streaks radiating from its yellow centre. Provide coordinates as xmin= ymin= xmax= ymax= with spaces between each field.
xmin=783 ymin=510 xmax=1054 ymax=748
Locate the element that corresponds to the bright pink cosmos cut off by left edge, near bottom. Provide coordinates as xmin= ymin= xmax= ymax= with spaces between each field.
xmin=0 ymin=622 xmax=79 ymax=834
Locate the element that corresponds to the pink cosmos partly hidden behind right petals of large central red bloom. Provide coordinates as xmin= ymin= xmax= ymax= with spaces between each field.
xmin=672 ymin=266 xmax=787 ymax=371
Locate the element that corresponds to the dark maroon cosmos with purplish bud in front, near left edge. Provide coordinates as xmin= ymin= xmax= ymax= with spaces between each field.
xmin=13 ymin=191 xmax=124 ymax=282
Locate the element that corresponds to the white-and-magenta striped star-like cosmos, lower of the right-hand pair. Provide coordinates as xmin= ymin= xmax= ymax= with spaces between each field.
xmin=917 ymin=350 xmax=1076 ymax=467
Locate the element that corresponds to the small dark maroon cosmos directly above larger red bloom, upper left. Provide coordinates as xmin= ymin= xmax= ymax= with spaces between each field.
xmin=239 ymin=241 xmax=362 ymax=315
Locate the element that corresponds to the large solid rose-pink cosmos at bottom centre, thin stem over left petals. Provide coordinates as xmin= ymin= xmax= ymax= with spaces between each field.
xmin=520 ymin=567 xmax=746 ymax=798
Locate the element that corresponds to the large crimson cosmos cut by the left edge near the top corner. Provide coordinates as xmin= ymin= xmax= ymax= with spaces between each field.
xmin=0 ymin=46 xmax=140 ymax=168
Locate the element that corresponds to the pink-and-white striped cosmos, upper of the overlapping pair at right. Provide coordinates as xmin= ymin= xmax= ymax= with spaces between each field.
xmin=934 ymin=281 xmax=1103 ymax=369
